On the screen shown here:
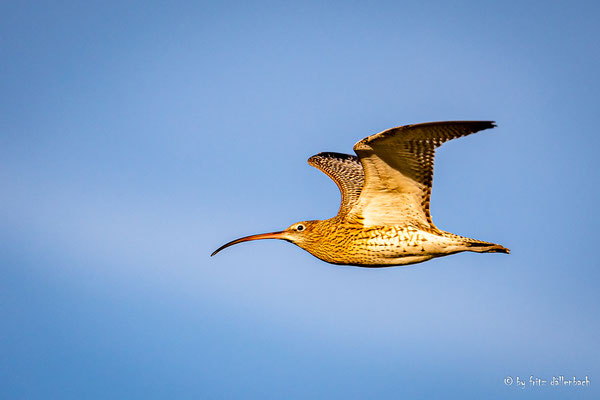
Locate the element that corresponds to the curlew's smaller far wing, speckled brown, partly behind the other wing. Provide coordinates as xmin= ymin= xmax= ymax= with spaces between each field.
xmin=308 ymin=153 xmax=365 ymax=216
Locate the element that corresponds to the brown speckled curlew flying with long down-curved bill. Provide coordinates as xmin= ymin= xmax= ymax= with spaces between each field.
xmin=211 ymin=121 xmax=510 ymax=267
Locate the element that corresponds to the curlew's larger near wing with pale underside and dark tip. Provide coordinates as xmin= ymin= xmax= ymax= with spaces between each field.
xmin=350 ymin=121 xmax=495 ymax=229
